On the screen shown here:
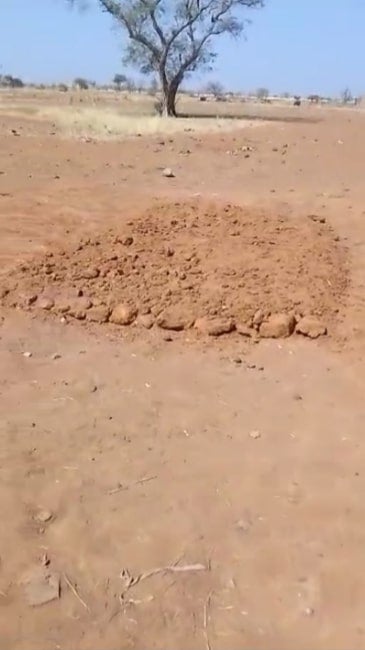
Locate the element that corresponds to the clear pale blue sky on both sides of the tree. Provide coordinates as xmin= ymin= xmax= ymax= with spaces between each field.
xmin=0 ymin=0 xmax=365 ymax=95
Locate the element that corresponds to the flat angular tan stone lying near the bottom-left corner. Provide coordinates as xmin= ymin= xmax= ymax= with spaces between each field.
xmin=21 ymin=566 xmax=60 ymax=607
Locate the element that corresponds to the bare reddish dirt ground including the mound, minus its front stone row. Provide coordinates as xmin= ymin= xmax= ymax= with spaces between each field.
xmin=0 ymin=107 xmax=365 ymax=650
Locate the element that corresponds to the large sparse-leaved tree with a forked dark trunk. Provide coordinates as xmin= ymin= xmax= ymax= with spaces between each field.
xmin=68 ymin=0 xmax=265 ymax=116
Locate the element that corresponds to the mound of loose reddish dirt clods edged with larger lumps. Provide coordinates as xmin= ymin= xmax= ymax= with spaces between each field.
xmin=2 ymin=202 xmax=347 ymax=336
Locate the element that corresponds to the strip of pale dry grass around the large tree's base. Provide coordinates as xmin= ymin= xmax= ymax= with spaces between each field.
xmin=0 ymin=89 xmax=328 ymax=139
